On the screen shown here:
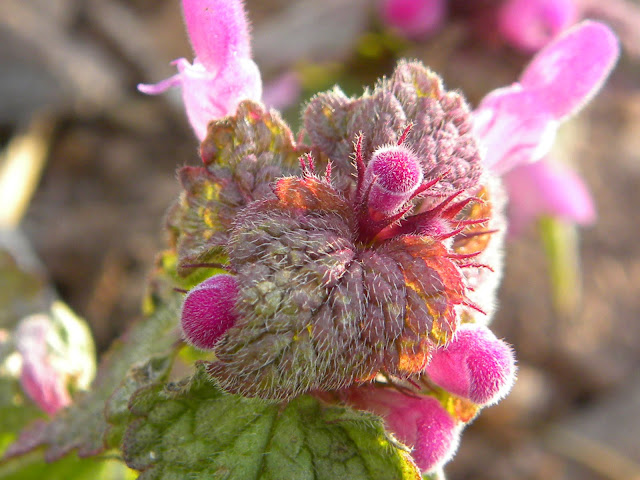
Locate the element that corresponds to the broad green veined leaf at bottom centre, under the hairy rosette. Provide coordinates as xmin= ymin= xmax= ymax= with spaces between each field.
xmin=123 ymin=364 xmax=421 ymax=480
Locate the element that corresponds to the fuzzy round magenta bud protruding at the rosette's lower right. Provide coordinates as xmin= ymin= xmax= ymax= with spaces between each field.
xmin=425 ymin=324 xmax=516 ymax=405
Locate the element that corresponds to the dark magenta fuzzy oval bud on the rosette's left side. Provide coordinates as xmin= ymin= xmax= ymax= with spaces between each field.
xmin=180 ymin=275 xmax=238 ymax=350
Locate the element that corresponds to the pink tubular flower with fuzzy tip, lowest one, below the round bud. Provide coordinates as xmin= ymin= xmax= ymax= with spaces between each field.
xmin=346 ymin=386 xmax=462 ymax=472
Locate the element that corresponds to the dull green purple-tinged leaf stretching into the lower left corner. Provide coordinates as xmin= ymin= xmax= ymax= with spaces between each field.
xmin=7 ymin=294 xmax=181 ymax=461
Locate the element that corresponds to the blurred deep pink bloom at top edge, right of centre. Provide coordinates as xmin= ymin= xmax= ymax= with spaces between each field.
xmin=380 ymin=0 xmax=446 ymax=37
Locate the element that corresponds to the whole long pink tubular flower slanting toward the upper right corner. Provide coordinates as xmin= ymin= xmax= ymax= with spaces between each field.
xmin=474 ymin=21 xmax=619 ymax=174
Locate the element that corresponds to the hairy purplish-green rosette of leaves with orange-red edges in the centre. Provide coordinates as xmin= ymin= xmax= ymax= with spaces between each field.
xmin=168 ymin=63 xmax=502 ymax=400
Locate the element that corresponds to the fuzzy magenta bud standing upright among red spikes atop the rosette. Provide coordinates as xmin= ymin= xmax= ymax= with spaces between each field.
xmin=364 ymin=145 xmax=423 ymax=215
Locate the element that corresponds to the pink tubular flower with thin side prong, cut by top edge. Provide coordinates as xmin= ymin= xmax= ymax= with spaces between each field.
xmin=138 ymin=0 xmax=262 ymax=140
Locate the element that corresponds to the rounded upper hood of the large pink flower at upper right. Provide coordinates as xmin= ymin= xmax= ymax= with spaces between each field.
xmin=520 ymin=20 xmax=620 ymax=119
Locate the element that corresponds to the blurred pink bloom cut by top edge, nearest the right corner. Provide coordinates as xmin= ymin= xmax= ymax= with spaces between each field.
xmin=498 ymin=0 xmax=578 ymax=52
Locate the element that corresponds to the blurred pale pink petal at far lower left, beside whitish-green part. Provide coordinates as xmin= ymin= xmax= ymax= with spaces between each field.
xmin=15 ymin=315 xmax=71 ymax=415
